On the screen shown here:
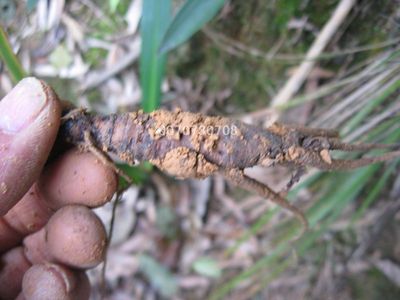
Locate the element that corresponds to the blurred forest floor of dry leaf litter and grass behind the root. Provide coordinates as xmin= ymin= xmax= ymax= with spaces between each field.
xmin=0 ymin=0 xmax=400 ymax=299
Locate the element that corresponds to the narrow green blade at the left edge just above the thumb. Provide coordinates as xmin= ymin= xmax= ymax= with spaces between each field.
xmin=0 ymin=27 xmax=26 ymax=83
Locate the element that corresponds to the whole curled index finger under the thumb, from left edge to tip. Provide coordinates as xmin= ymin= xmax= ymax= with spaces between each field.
xmin=0 ymin=150 xmax=118 ymax=253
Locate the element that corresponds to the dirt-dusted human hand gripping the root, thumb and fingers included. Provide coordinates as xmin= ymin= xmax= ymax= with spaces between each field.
xmin=0 ymin=78 xmax=118 ymax=300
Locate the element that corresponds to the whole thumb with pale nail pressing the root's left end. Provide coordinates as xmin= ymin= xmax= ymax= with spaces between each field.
xmin=0 ymin=78 xmax=60 ymax=216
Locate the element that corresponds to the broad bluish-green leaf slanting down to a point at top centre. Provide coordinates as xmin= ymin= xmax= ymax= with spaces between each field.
xmin=160 ymin=0 xmax=225 ymax=53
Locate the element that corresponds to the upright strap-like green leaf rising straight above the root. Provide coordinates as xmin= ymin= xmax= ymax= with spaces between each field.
xmin=140 ymin=0 xmax=171 ymax=112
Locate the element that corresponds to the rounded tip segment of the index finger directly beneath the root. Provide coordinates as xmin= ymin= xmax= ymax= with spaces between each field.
xmin=38 ymin=149 xmax=118 ymax=209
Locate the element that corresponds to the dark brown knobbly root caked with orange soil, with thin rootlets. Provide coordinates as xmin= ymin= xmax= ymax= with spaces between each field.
xmin=60 ymin=109 xmax=400 ymax=234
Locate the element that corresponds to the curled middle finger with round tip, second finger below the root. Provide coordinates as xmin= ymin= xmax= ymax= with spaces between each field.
xmin=23 ymin=205 xmax=107 ymax=269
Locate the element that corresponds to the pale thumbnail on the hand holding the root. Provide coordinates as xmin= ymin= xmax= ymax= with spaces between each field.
xmin=0 ymin=77 xmax=47 ymax=134
